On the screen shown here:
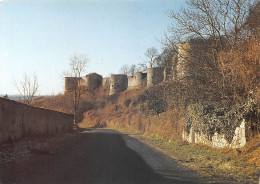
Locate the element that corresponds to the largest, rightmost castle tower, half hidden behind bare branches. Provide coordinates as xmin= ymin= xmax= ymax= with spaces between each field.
xmin=174 ymin=39 xmax=219 ymax=86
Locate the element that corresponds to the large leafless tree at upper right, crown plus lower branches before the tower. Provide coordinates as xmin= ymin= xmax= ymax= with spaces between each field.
xmin=166 ymin=0 xmax=253 ymax=99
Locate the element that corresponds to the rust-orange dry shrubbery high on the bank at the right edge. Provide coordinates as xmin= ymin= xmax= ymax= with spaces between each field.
xmin=219 ymin=39 xmax=260 ymax=100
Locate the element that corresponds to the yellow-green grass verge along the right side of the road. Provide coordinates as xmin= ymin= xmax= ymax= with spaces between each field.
xmin=105 ymin=126 xmax=260 ymax=183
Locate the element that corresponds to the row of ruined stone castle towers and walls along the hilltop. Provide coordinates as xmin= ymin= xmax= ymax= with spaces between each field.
xmin=65 ymin=42 xmax=202 ymax=95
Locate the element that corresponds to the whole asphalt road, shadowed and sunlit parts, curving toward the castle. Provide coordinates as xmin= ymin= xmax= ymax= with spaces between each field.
xmin=2 ymin=129 xmax=208 ymax=184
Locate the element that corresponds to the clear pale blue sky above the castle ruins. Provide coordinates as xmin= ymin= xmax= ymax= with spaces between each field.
xmin=0 ymin=0 xmax=184 ymax=95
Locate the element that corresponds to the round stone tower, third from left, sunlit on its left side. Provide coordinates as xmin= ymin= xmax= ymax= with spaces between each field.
xmin=109 ymin=74 xmax=128 ymax=95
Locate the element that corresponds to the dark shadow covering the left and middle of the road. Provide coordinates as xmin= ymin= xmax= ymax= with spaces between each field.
xmin=2 ymin=129 xmax=203 ymax=184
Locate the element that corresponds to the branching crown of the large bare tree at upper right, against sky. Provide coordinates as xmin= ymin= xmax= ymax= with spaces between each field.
xmin=169 ymin=0 xmax=253 ymax=51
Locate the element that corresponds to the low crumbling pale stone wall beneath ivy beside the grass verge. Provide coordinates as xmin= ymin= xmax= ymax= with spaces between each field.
xmin=182 ymin=119 xmax=246 ymax=148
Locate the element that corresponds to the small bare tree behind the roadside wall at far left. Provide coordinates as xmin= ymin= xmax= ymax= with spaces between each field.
xmin=14 ymin=73 xmax=39 ymax=104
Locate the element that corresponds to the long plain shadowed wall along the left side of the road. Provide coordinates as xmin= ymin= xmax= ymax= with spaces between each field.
xmin=0 ymin=98 xmax=73 ymax=142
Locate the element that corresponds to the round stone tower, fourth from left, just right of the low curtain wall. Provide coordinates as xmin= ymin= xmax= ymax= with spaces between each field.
xmin=147 ymin=67 xmax=164 ymax=86
